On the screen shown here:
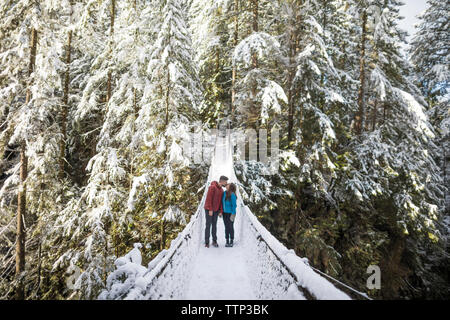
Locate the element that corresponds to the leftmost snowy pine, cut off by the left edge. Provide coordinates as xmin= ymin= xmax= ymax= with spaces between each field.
xmin=0 ymin=2 xmax=73 ymax=299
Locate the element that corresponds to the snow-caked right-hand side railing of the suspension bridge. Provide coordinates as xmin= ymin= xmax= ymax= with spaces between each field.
xmin=237 ymin=205 xmax=350 ymax=300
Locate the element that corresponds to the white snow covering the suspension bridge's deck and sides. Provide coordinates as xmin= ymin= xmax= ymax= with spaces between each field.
xmin=99 ymin=133 xmax=350 ymax=300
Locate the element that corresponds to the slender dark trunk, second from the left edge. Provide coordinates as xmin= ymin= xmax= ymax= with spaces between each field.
xmin=59 ymin=24 xmax=72 ymax=179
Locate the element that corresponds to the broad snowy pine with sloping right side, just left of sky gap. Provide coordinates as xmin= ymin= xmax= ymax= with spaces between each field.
xmin=338 ymin=1 xmax=443 ymax=297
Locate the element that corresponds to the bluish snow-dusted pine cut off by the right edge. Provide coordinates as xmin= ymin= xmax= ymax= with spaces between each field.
xmin=409 ymin=1 xmax=450 ymax=290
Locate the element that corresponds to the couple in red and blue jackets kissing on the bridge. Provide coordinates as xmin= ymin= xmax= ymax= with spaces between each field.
xmin=205 ymin=176 xmax=236 ymax=248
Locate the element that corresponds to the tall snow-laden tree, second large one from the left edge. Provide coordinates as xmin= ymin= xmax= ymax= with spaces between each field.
xmin=45 ymin=1 xmax=163 ymax=298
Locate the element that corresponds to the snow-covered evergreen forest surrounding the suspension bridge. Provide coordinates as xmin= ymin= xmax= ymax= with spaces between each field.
xmin=0 ymin=0 xmax=450 ymax=300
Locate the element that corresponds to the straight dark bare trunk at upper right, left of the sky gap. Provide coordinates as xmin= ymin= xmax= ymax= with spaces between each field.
xmin=355 ymin=9 xmax=367 ymax=134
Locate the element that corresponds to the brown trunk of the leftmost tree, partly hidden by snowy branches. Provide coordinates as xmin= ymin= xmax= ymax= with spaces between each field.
xmin=16 ymin=28 xmax=37 ymax=300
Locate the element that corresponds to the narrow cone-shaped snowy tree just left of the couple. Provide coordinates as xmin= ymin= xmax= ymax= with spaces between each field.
xmin=128 ymin=0 xmax=202 ymax=249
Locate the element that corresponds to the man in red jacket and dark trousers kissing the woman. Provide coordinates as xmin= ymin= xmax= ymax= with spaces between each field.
xmin=204 ymin=176 xmax=228 ymax=248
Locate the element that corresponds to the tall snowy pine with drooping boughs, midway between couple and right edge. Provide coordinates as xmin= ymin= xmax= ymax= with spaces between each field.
xmin=278 ymin=1 xmax=354 ymax=275
